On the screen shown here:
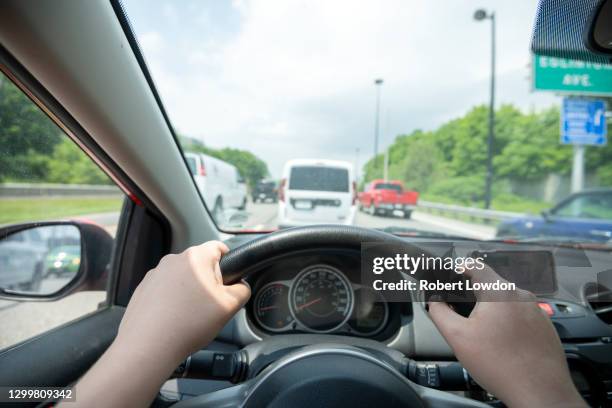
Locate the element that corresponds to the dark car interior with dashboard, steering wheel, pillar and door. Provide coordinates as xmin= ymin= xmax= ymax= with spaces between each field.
xmin=0 ymin=0 xmax=612 ymax=407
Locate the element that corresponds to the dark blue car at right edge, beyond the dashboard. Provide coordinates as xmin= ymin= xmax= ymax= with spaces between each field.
xmin=497 ymin=189 xmax=612 ymax=243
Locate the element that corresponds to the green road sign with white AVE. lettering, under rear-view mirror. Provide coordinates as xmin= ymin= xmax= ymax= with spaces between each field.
xmin=532 ymin=55 xmax=612 ymax=95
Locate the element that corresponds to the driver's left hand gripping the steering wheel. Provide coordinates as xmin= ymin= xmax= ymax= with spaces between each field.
xmin=117 ymin=241 xmax=251 ymax=364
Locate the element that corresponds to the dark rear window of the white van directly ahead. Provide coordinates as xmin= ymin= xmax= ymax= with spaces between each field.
xmin=289 ymin=166 xmax=349 ymax=192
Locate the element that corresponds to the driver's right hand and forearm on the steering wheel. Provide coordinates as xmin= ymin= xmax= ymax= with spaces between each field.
xmin=429 ymin=266 xmax=587 ymax=407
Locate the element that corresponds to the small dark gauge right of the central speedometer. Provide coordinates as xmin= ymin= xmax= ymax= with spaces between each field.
xmin=349 ymin=288 xmax=389 ymax=336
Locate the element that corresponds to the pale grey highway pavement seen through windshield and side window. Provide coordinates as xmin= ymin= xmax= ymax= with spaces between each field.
xmin=0 ymin=203 xmax=494 ymax=349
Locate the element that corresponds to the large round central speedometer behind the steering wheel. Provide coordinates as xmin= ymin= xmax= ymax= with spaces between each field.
xmin=290 ymin=265 xmax=353 ymax=333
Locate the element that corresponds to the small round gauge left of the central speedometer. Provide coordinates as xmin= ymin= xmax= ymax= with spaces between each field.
xmin=254 ymin=282 xmax=293 ymax=332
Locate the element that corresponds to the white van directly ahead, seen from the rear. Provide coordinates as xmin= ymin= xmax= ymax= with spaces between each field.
xmin=278 ymin=159 xmax=357 ymax=228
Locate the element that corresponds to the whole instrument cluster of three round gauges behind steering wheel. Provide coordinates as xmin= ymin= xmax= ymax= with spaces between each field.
xmin=248 ymin=253 xmax=399 ymax=337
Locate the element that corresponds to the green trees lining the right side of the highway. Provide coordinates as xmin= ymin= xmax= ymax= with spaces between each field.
xmin=363 ymin=99 xmax=612 ymax=207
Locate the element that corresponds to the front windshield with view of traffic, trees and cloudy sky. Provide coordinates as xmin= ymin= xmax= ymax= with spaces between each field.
xmin=125 ymin=0 xmax=612 ymax=244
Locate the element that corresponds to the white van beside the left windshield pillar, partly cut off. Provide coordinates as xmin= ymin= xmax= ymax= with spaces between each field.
xmin=185 ymin=153 xmax=247 ymax=221
